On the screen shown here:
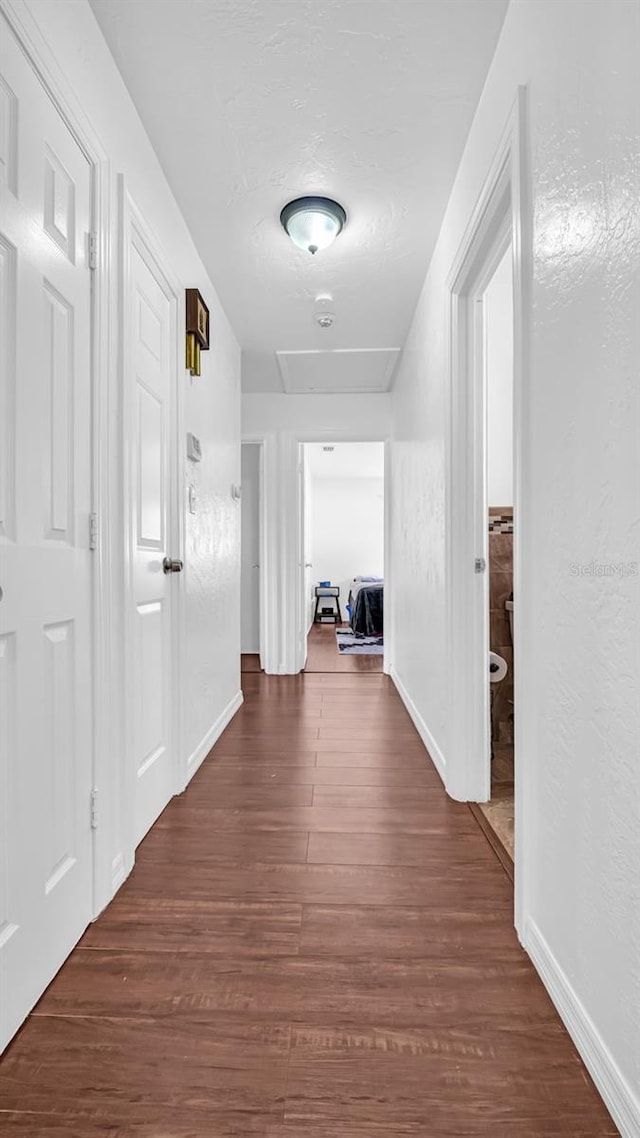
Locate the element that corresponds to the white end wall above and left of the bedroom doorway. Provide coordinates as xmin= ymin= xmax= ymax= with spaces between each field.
xmin=243 ymin=394 xmax=392 ymax=674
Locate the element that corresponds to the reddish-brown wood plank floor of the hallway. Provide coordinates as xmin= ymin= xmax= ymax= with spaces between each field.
xmin=0 ymin=674 xmax=616 ymax=1138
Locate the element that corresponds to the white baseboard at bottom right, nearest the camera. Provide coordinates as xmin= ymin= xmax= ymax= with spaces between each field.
xmin=524 ymin=917 xmax=640 ymax=1138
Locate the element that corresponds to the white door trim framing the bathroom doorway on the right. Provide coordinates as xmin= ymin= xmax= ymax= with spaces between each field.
xmin=446 ymin=88 xmax=528 ymax=935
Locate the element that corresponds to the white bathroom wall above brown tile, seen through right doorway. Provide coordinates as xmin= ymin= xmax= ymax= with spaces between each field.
xmin=484 ymin=245 xmax=514 ymax=505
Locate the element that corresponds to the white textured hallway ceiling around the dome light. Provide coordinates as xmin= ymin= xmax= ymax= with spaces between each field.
xmin=91 ymin=0 xmax=507 ymax=391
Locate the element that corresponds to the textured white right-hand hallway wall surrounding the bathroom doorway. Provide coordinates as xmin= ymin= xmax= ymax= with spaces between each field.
xmin=391 ymin=0 xmax=640 ymax=1136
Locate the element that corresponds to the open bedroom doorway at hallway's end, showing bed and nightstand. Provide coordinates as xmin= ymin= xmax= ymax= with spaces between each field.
xmin=301 ymin=440 xmax=385 ymax=674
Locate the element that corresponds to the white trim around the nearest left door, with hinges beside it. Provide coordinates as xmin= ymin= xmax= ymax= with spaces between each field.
xmin=0 ymin=0 xmax=115 ymax=916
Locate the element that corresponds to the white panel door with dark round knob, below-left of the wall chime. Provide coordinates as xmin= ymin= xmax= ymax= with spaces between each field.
xmin=128 ymin=230 xmax=175 ymax=844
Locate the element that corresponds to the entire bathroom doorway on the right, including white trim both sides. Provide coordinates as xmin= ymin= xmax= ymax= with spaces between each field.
xmin=446 ymin=97 xmax=523 ymax=910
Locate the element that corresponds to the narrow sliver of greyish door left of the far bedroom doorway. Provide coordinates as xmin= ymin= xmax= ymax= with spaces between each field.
xmin=240 ymin=443 xmax=261 ymax=652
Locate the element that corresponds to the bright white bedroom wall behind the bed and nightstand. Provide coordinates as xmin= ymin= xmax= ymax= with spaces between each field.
xmin=311 ymin=471 xmax=385 ymax=620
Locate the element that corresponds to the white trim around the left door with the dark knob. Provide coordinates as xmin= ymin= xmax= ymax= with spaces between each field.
xmin=118 ymin=174 xmax=185 ymax=837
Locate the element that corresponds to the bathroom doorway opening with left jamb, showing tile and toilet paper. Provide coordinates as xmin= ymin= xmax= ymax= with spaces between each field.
xmin=448 ymin=219 xmax=517 ymax=877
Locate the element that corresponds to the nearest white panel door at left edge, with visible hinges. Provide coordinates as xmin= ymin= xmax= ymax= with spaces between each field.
xmin=0 ymin=16 xmax=92 ymax=1046
